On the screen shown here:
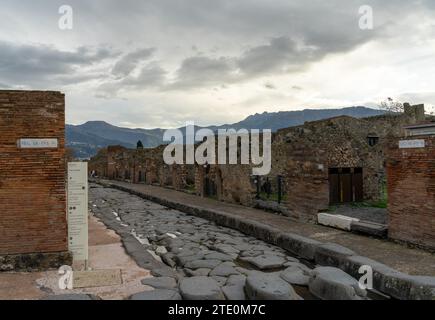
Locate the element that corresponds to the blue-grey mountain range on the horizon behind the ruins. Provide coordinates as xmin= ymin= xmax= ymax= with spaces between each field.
xmin=66 ymin=107 xmax=384 ymax=159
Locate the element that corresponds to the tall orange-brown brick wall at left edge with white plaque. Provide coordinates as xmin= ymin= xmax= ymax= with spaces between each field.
xmin=0 ymin=91 xmax=68 ymax=255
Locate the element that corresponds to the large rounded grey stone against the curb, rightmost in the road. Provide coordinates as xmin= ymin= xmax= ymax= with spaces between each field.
xmin=309 ymin=267 xmax=367 ymax=300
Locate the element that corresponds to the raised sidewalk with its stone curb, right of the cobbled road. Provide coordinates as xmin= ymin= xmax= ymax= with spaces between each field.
xmin=99 ymin=180 xmax=435 ymax=299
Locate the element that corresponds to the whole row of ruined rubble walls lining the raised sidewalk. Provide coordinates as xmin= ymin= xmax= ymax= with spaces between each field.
xmin=91 ymin=105 xmax=424 ymax=221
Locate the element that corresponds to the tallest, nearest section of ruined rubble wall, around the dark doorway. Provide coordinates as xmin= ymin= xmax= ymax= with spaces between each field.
xmin=271 ymin=114 xmax=417 ymax=221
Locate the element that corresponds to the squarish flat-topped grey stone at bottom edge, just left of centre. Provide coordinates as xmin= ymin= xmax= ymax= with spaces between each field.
xmin=179 ymin=277 xmax=225 ymax=300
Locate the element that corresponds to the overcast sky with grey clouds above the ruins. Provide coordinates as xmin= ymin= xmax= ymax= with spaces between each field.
xmin=0 ymin=0 xmax=435 ymax=128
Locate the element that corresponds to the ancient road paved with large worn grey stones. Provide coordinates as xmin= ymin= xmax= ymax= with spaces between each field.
xmin=90 ymin=185 xmax=365 ymax=300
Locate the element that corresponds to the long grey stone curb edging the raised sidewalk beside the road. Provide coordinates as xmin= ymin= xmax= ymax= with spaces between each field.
xmin=100 ymin=182 xmax=435 ymax=300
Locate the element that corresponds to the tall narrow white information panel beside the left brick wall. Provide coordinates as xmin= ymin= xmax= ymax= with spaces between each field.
xmin=67 ymin=162 xmax=88 ymax=261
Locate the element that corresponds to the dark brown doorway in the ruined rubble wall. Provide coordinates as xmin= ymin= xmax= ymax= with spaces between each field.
xmin=329 ymin=168 xmax=363 ymax=204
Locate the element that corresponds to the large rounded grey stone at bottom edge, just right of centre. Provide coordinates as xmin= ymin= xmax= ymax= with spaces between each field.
xmin=245 ymin=273 xmax=302 ymax=300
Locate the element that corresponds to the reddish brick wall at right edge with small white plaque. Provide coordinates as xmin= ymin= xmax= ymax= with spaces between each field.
xmin=387 ymin=136 xmax=435 ymax=249
